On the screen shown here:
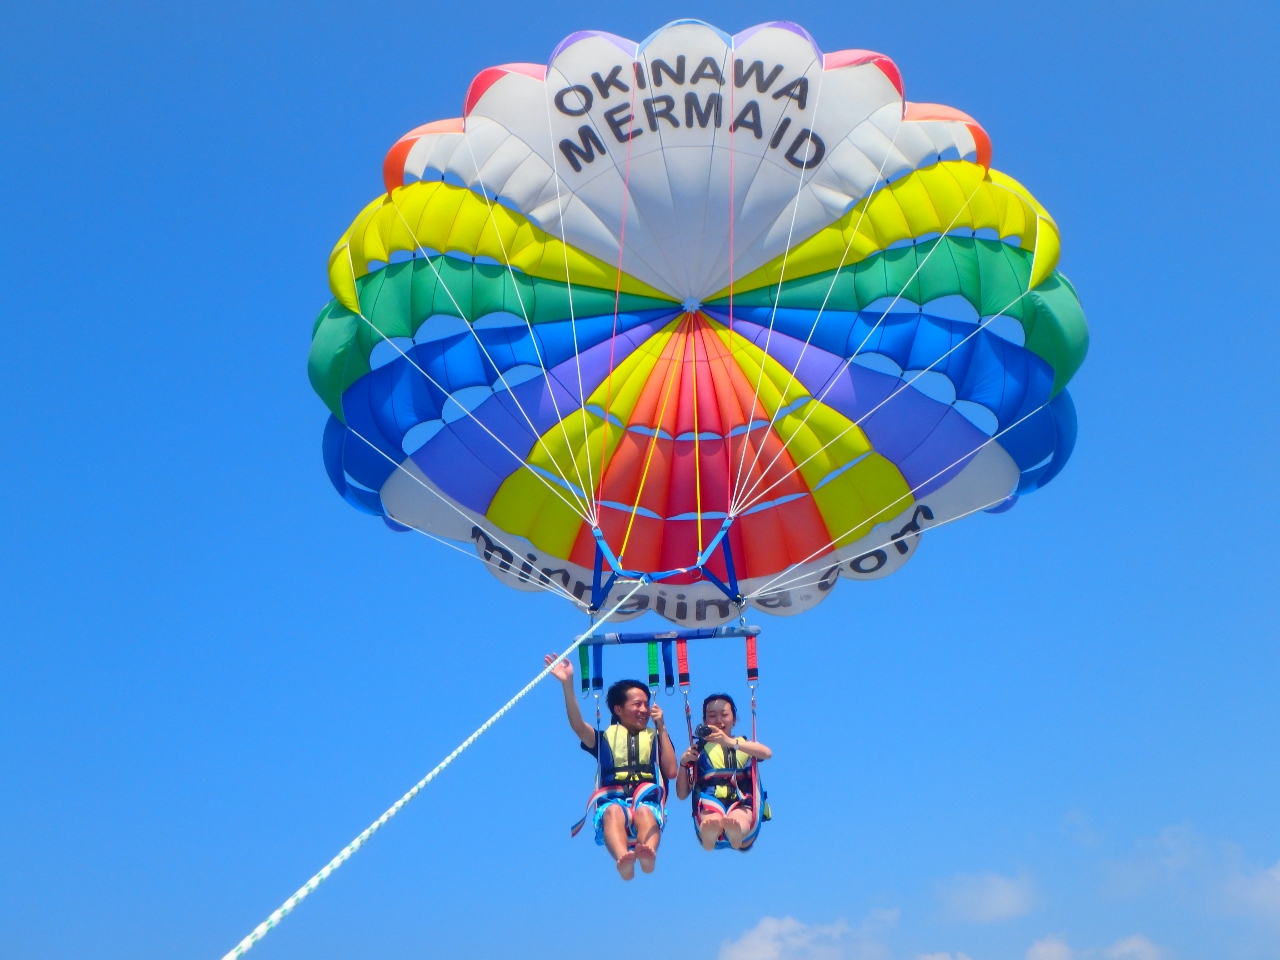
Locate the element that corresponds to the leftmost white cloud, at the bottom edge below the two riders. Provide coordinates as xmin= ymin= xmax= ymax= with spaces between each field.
xmin=719 ymin=910 xmax=901 ymax=960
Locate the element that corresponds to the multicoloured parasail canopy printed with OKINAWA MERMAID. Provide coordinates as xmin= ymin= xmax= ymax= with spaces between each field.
xmin=310 ymin=20 xmax=1088 ymax=626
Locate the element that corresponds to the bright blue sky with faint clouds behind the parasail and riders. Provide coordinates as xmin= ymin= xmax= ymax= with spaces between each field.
xmin=0 ymin=0 xmax=1280 ymax=960
